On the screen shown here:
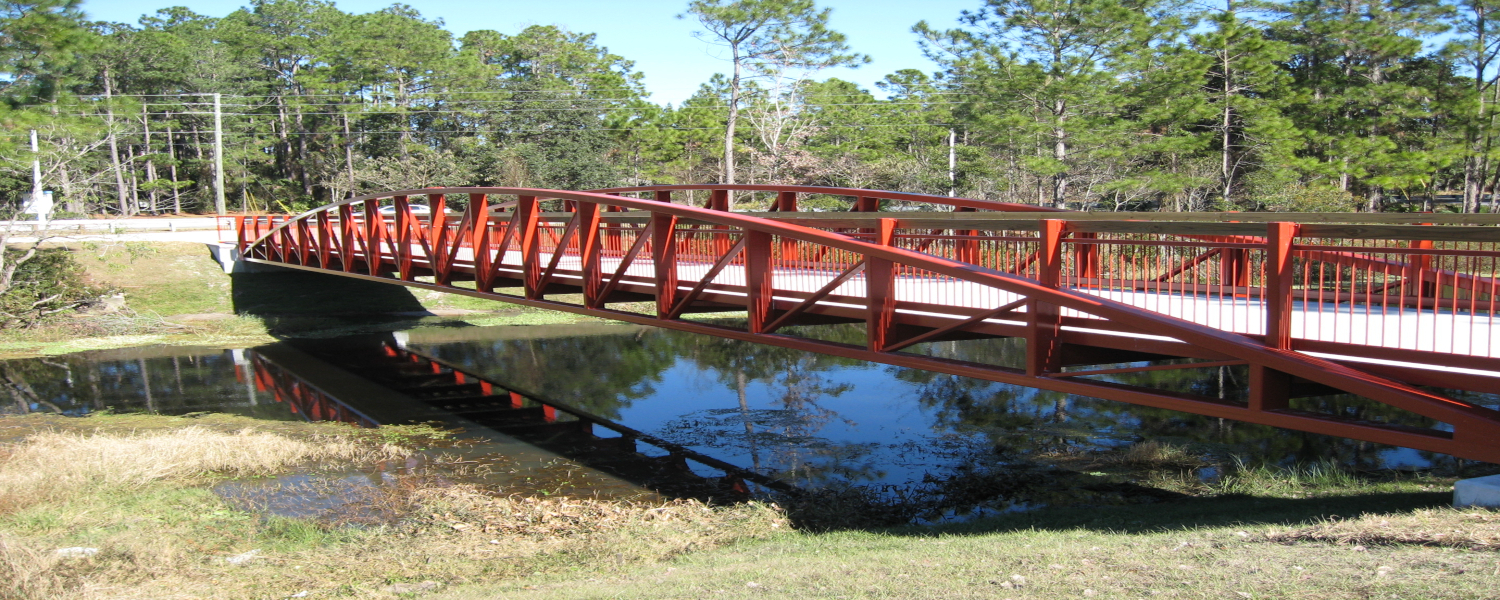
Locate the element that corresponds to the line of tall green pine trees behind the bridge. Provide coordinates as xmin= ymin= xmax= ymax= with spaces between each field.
xmin=0 ymin=0 xmax=1500 ymax=215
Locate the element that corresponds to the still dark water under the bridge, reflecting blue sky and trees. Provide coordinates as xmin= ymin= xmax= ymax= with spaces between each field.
xmin=0 ymin=324 xmax=1497 ymax=489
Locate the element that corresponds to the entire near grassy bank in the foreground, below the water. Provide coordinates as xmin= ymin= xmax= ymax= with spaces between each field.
xmin=0 ymin=416 xmax=1500 ymax=599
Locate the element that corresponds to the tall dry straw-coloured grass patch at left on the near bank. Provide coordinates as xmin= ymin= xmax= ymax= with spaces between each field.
xmin=0 ymin=426 xmax=407 ymax=513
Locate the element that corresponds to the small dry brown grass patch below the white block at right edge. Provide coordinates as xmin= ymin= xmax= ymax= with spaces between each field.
xmin=1266 ymin=509 xmax=1500 ymax=551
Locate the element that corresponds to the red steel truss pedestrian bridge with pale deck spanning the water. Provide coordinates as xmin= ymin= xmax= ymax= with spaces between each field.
xmin=228 ymin=185 xmax=1500 ymax=462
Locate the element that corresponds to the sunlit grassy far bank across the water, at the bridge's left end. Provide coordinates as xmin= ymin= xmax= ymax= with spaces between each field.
xmin=0 ymin=242 xmax=597 ymax=359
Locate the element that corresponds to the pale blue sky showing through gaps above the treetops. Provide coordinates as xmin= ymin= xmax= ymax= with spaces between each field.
xmin=83 ymin=0 xmax=983 ymax=105
